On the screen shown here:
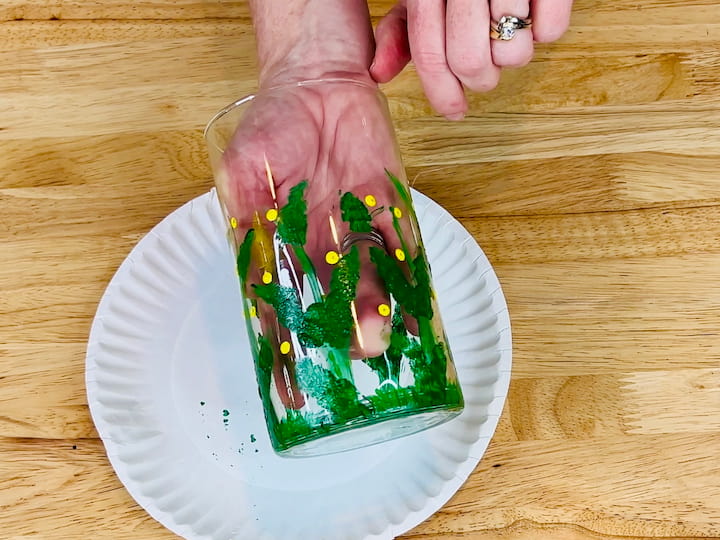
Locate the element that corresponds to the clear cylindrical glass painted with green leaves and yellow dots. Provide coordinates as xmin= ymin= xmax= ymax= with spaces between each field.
xmin=205 ymin=79 xmax=463 ymax=456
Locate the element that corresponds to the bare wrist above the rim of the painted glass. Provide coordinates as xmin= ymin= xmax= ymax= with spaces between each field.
xmin=250 ymin=0 xmax=374 ymax=88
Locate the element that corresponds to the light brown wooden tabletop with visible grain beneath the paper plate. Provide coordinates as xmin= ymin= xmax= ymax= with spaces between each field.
xmin=0 ymin=0 xmax=720 ymax=540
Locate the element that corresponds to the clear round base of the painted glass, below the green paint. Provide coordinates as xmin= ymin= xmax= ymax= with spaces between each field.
xmin=276 ymin=405 xmax=463 ymax=458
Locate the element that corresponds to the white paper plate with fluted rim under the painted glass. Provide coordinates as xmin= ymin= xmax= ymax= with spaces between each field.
xmin=86 ymin=191 xmax=511 ymax=540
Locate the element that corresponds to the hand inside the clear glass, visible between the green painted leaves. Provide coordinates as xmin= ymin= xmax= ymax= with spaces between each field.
xmin=216 ymin=80 xmax=417 ymax=406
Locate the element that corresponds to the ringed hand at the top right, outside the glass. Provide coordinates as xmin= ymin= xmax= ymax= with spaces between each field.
xmin=370 ymin=0 xmax=572 ymax=120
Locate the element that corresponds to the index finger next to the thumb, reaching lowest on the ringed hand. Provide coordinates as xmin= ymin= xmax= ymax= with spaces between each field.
xmin=407 ymin=0 xmax=467 ymax=120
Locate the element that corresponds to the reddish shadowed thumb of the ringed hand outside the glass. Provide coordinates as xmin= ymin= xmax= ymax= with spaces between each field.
xmin=370 ymin=2 xmax=410 ymax=83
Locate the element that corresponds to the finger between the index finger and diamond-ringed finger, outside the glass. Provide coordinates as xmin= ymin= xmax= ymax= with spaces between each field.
xmin=446 ymin=0 xmax=500 ymax=92
